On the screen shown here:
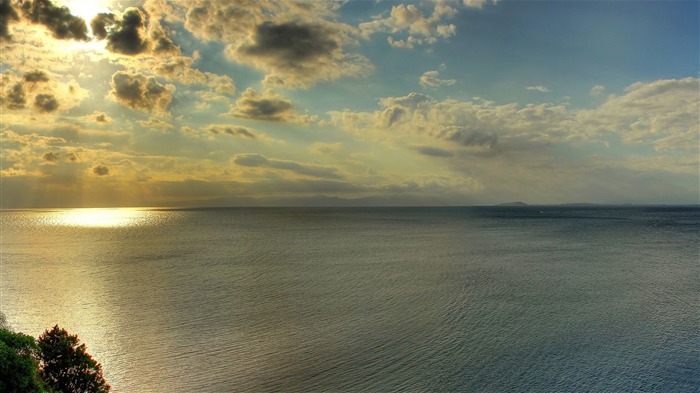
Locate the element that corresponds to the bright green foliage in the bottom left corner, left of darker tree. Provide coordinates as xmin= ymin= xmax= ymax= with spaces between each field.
xmin=0 ymin=326 xmax=44 ymax=393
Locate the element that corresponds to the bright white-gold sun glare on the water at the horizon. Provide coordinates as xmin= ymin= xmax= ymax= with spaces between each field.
xmin=54 ymin=208 xmax=148 ymax=227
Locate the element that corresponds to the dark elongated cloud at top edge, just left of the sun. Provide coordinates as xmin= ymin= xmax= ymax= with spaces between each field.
xmin=21 ymin=0 xmax=88 ymax=41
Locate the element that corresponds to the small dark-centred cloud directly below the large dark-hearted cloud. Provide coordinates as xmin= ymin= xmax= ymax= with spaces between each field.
xmin=231 ymin=87 xmax=292 ymax=121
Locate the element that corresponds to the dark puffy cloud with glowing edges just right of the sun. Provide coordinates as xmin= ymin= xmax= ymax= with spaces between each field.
xmin=90 ymin=7 xmax=179 ymax=55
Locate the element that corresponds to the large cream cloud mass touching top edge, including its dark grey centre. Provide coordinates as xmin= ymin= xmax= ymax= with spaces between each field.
xmin=170 ymin=0 xmax=372 ymax=88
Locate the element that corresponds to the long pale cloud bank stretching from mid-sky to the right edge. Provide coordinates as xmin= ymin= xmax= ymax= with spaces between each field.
xmin=329 ymin=78 xmax=700 ymax=164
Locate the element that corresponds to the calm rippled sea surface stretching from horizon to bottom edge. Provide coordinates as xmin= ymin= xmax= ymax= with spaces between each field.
xmin=0 ymin=207 xmax=700 ymax=392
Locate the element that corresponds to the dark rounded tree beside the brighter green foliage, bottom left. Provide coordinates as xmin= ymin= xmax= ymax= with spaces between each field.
xmin=37 ymin=325 xmax=110 ymax=393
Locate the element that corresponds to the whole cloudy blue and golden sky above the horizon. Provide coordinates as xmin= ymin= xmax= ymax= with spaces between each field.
xmin=0 ymin=0 xmax=700 ymax=208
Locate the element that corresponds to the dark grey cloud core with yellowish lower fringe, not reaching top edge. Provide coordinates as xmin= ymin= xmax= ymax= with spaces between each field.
xmin=226 ymin=21 xmax=372 ymax=87
